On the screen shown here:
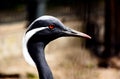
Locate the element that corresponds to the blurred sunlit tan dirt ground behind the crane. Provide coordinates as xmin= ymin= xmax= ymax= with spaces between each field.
xmin=0 ymin=17 xmax=120 ymax=79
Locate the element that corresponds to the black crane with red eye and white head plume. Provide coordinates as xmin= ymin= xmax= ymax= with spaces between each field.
xmin=23 ymin=15 xmax=91 ymax=79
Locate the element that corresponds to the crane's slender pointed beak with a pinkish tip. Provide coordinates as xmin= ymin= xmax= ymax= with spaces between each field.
xmin=63 ymin=28 xmax=91 ymax=39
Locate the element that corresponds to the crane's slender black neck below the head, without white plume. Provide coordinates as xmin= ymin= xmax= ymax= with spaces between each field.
xmin=28 ymin=42 xmax=53 ymax=79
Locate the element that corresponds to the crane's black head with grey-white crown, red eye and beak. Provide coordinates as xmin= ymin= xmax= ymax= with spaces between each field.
xmin=26 ymin=16 xmax=91 ymax=44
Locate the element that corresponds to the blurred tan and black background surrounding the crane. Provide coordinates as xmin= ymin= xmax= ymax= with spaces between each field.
xmin=0 ymin=0 xmax=120 ymax=79
